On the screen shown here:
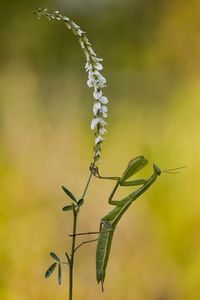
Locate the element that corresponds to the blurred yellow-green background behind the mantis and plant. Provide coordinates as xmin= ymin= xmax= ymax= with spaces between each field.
xmin=0 ymin=0 xmax=200 ymax=300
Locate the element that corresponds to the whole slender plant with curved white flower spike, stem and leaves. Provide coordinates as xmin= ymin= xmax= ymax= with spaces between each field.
xmin=35 ymin=9 xmax=108 ymax=300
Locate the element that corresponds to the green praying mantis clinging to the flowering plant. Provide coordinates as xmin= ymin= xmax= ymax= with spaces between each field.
xmin=92 ymin=155 xmax=161 ymax=290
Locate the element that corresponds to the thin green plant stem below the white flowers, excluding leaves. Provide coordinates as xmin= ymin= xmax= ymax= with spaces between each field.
xmin=69 ymin=172 xmax=92 ymax=300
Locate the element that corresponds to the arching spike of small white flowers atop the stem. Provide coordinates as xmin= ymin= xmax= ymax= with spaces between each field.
xmin=36 ymin=9 xmax=108 ymax=164
